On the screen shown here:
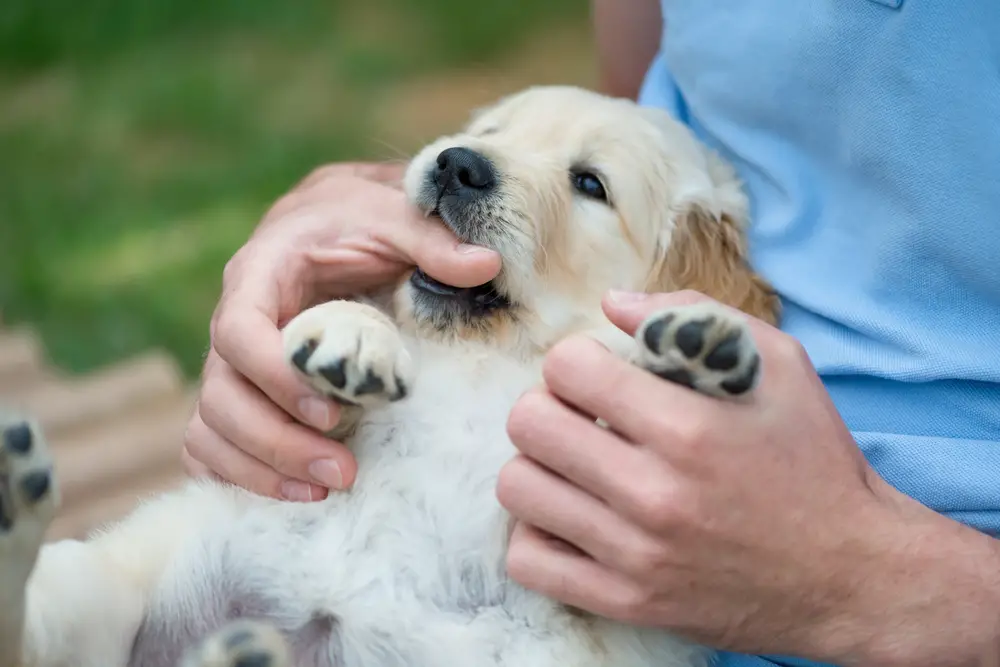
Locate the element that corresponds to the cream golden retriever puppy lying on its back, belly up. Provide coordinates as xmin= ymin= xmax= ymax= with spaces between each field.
xmin=0 ymin=87 xmax=778 ymax=667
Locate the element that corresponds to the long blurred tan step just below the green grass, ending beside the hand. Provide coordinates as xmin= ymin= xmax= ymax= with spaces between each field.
xmin=0 ymin=351 xmax=184 ymax=438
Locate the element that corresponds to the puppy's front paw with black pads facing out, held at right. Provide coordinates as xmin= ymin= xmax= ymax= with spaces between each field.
xmin=635 ymin=303 xmax=760 ymax=398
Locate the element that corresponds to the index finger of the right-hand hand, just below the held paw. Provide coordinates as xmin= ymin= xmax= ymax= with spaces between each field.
xmin=542 ymin=336 xmax=720 ymax=452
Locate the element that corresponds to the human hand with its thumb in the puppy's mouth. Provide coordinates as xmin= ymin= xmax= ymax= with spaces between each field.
xmin=183 ymin=164 xmax=500 ymax=501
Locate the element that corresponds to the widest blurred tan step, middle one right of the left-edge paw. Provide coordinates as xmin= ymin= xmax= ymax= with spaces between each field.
xmin=50 ymin=393 xmax=194 ymax=508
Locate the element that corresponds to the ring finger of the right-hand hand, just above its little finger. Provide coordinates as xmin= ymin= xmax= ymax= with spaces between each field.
xmin=497 ymin=457 xmax=652 ymax=571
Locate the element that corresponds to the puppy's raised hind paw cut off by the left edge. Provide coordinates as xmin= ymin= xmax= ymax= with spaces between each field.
xmin=0 ymin=413 xmax=58 ymax=636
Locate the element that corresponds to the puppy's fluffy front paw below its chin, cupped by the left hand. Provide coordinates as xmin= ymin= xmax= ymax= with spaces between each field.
xmin=283 ymin=301 xmax=413 ymax=407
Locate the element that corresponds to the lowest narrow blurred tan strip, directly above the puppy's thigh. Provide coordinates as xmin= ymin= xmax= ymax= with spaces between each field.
xmin=45 ymin=470 xmax=186 ymax=542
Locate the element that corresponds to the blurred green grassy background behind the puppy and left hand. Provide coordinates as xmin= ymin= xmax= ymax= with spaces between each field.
xmin=0 ymin=0 xmax=594 ymax=377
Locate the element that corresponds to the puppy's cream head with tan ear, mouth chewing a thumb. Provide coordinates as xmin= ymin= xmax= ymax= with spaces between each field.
xmin=397 ymin=87 xmax=777 ymax=346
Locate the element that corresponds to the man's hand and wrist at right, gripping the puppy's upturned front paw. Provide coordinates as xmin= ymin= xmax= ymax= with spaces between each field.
xmin=497 ymin=294 xmax=1000 ymax=665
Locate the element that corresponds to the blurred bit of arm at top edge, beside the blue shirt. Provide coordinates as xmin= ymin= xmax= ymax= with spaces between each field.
xmin=591 ymin=0 xmax=662 ymax=99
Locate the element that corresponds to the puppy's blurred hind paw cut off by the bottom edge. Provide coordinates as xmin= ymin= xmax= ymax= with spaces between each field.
xmin=182 ymin=620 xmax=291 ymax=667
